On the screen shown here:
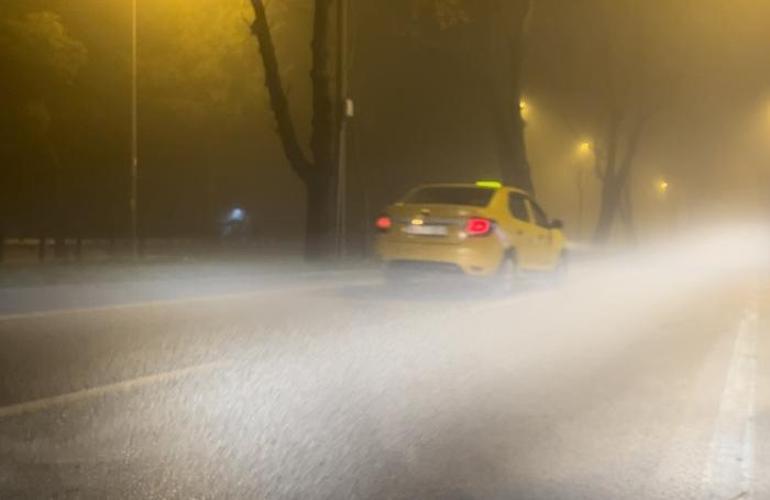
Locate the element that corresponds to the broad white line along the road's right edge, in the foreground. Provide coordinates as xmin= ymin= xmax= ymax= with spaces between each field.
xmin=701 ymin=304 xmax=758 ymax=500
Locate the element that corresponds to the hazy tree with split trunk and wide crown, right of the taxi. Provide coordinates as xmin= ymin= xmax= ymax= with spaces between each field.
xmin=528 ymin=0 xmax=686 ymax=243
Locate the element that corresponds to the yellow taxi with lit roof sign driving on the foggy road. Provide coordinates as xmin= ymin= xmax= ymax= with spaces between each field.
xmin=375 ymin=181 xmax=566 ymax=282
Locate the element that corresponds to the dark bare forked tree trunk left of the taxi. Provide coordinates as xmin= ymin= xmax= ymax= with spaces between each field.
xmin=251 ymin=0 xmax=337 ymax=258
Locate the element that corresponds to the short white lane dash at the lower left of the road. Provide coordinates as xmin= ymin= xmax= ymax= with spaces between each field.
xmin=0 ymin=362 xmax=227 ymax=418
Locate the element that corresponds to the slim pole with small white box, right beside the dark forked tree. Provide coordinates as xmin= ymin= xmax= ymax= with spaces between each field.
xmin=336 ymin=0 xmax=354 ymax=257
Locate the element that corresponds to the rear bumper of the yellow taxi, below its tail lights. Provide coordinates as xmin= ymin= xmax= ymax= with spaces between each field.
xmin=376 ymin=237 xmax=503 ymax=276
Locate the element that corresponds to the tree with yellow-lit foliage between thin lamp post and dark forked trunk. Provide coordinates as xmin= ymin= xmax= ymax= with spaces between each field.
xmin=139 ymin=0 xmax=264 ymax=235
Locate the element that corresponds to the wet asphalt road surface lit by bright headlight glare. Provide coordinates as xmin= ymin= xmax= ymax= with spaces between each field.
xmin=0 ymin=235 xmax=770 ymax=499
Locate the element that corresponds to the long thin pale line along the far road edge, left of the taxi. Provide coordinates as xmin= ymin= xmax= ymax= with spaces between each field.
xmin=0 ymin=279 xmax=379 ymax=322
